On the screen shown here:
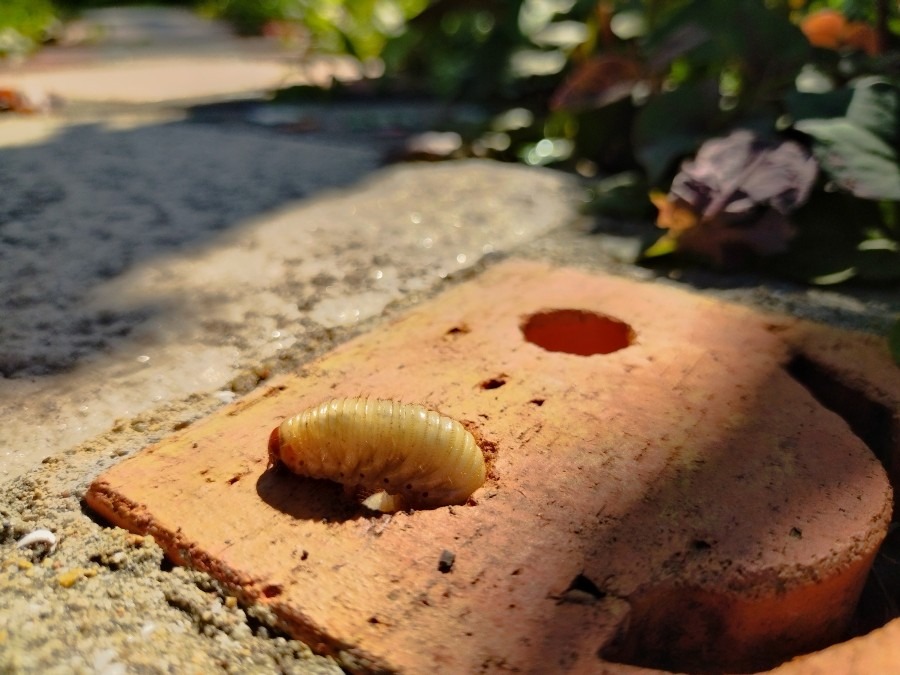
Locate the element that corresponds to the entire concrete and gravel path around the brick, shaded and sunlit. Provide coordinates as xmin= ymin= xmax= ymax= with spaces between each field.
xmin=0 ymin=10 xmax=900 ymax=673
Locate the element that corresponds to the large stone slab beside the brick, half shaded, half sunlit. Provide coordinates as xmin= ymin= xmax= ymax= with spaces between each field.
xmin=0 ymin=156 xmax=574 ymax=478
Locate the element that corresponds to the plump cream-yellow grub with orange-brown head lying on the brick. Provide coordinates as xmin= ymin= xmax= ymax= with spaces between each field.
xmin=269 ymin=398 xmax=486 ymax=511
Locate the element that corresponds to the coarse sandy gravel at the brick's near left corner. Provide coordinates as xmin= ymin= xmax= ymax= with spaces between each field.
xmin=0 ymin=398 xmax=340 ymax=675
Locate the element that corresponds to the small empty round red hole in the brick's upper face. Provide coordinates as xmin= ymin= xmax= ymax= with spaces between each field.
xmin=521 ymin=309 xmax=635 ymax=356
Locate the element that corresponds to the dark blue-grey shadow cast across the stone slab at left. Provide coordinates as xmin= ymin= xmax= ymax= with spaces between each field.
xmin=0 ymin=116 xmax=377 ymax=377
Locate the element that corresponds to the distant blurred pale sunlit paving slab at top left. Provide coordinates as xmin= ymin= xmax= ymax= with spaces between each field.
xmin=0 ymin=7 xmax=357 ymax=104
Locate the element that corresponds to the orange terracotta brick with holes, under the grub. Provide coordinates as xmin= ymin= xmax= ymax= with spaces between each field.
xmin=87 ymin=261 xmax=900 ymax=673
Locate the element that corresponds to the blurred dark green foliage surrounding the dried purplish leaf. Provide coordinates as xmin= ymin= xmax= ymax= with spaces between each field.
xmin=0 ymin=0 xmax=900 ymax=283
